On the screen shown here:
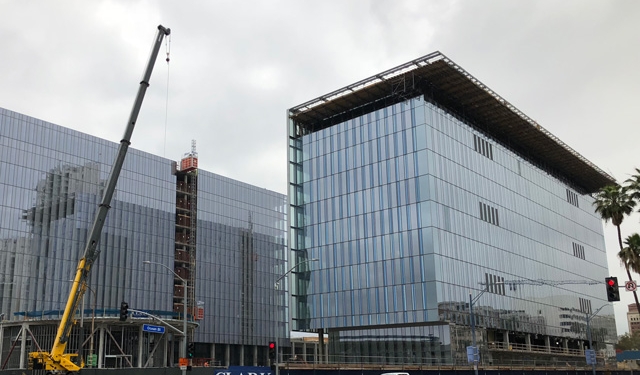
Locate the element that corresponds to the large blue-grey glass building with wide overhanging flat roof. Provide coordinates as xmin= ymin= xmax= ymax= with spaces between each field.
xmin=288 ymin=53 xmax=616 ymax=364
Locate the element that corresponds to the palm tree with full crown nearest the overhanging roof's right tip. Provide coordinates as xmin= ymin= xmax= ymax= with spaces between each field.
xmin=593 ymin=185 xmax=640 ymax=311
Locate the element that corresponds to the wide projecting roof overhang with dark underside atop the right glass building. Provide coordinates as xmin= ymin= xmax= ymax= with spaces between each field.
xmin=289 ymin=52 xmax=616 ymax=193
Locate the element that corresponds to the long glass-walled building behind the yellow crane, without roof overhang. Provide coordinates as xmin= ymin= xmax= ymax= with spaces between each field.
xmin=0 ymin=108 xmax=288 ymax=365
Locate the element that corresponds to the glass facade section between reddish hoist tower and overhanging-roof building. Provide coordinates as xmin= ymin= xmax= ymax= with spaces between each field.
xmin=196 ymin=171 xmax=289 ymax=346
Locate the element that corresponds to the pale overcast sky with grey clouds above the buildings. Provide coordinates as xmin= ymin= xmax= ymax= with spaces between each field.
xmin=0 ymin=0 xmax=640 ymax=334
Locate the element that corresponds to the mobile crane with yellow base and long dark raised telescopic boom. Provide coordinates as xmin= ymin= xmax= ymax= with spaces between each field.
xmin=29 ymin=25 xmax=171 ymax=374
